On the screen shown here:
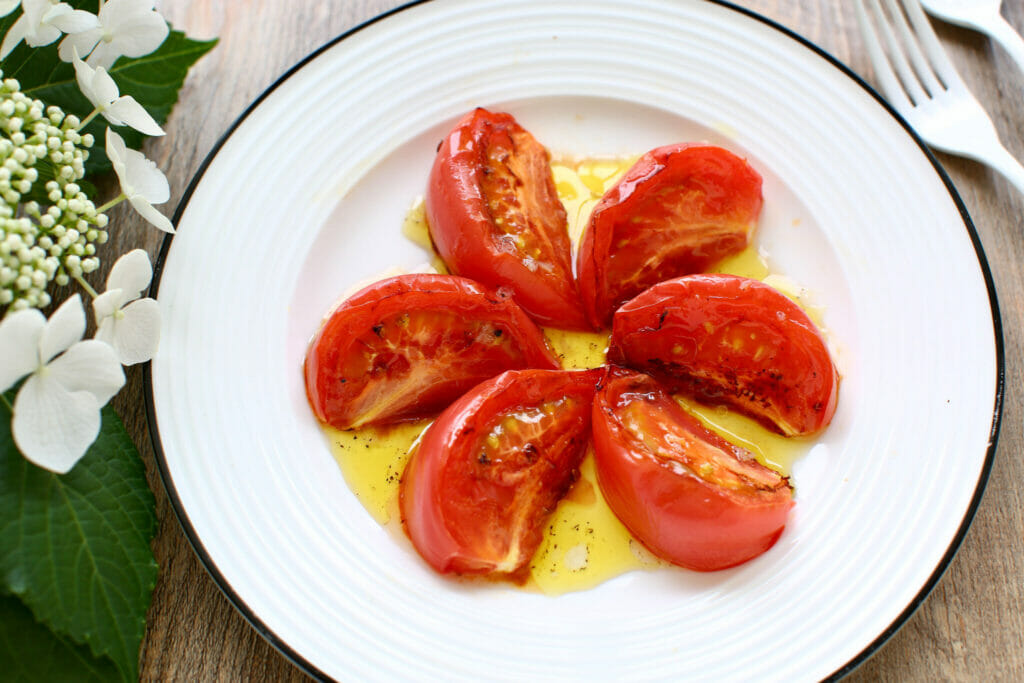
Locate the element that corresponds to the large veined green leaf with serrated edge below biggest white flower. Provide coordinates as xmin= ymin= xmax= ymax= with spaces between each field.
xmin=0 ymin=391 xmax=157 ymax=681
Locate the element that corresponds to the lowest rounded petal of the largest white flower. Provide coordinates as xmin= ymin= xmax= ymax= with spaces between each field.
xmin=11 ymin=375 xmax=99 ymax=474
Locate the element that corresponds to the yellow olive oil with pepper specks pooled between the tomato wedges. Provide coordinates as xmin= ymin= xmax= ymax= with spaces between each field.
xmin=326 ymin=157 xmax=812 ymax=595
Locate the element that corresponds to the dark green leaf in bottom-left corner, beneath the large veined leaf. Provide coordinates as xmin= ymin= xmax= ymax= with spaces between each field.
xmin=0 ymin=596 xmax=120 ymax=683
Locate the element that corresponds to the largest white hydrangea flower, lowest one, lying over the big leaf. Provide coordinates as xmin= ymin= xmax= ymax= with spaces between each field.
xmin=0 ymin=294 xmax=125 ymax=474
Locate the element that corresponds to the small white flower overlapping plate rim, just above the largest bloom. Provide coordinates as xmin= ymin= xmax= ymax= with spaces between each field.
xmin=92 ymin=249 xmax=160 ymax=366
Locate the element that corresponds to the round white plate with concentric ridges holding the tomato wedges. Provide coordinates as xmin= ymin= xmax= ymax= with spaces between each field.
xmin=150 ymin=0 xmax=1001 ymax=680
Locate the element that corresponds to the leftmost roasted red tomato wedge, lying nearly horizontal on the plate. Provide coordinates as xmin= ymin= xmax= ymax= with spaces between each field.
xmin=305 ymin=274 xmax=558 ymax=429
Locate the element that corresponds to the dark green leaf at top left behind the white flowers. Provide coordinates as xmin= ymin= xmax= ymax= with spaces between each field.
xmin=0 ymin=0 xmax=217 ymax=177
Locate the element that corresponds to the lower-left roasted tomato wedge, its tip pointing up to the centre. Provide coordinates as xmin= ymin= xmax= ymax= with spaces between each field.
xmin=400 ymin=370 xmax=603 ymax=580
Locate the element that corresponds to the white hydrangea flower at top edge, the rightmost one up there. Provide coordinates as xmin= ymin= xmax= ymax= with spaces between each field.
xmin=58 ymin=0 xmax=170 ymax=69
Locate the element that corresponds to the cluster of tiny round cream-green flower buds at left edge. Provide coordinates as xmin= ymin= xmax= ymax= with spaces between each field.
xmin=0 ymin=73 xmax=108 ymax=311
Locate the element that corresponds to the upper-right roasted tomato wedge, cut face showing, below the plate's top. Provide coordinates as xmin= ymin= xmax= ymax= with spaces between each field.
xmin=577 ymin=144 xmax=762 ymax=328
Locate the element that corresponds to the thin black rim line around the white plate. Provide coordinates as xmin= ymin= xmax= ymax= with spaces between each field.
xmin=142 ymin=0 xmax=1006 ymax=681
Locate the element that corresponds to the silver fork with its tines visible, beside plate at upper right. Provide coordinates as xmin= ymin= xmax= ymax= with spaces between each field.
xmin=856 ymin=0 xmax=1024 ymax=194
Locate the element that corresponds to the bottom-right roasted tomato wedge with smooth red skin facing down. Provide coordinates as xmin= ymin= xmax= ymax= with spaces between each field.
xmin=594 ymin=369 xmax=793 ymax=571
